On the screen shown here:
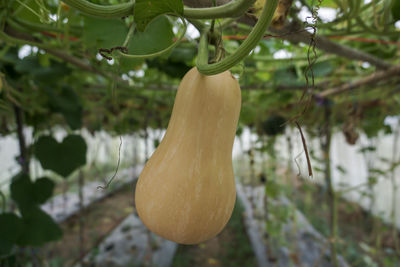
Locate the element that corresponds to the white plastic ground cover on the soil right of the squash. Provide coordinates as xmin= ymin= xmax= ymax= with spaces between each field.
xmin=236 ymin=184 xmax=348 ymax=267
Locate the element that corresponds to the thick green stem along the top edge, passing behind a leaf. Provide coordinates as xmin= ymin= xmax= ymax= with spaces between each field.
xmin=64 ymin=0 xmax=255 ymax=19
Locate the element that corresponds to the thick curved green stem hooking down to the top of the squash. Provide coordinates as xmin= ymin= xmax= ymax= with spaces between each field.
xmin=196 ymin=0 xmax=278 ymax=75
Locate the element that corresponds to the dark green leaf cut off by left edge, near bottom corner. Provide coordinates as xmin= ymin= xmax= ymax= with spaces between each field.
xmin=0 ymin=213 xmax=23 ymax=256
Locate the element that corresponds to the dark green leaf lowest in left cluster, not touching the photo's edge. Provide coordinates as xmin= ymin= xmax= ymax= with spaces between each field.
xmin=17 ymin=207 xmax=62 ymax=246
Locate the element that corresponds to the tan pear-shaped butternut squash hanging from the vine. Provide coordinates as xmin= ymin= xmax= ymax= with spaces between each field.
xmin=135 ymin=68 xmax=241 ymax=244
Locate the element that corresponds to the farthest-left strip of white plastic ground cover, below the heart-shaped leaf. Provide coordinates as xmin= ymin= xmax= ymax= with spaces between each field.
xmin=42 ymin=165 xmax=143 ymax=223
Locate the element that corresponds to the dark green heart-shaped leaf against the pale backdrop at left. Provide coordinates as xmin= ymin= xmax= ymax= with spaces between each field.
xmin=35 ymin=135 xmax=87 ymax=178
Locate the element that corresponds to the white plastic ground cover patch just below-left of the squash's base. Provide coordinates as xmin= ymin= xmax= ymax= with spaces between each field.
xmin=84 ymin=213 xmax=178 ymax=267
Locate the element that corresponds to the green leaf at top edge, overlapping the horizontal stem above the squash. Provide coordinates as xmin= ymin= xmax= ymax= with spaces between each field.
xmin=133 ymin=0 xmax=183 ymax=32
